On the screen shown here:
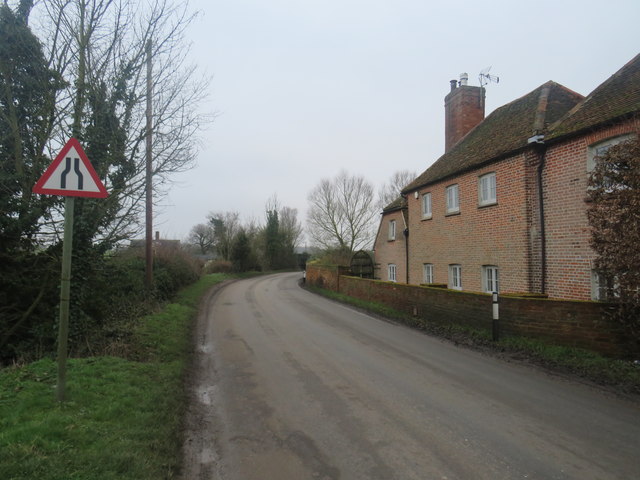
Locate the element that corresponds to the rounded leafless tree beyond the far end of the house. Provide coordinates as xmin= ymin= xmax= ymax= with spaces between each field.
xmin=307 ymin=171 xmax=378 ymax=252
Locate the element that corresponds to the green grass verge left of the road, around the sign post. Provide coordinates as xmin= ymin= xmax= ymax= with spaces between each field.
xmin=0 ymin=275 xmax=227 ymax=480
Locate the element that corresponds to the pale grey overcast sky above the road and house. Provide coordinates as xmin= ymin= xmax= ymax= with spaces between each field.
xmin=155 ymin=0 xmax=640 ymax=239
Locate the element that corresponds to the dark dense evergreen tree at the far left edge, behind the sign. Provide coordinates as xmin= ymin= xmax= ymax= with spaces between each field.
xmin=0 ymin=1 xmax=62 ymax=362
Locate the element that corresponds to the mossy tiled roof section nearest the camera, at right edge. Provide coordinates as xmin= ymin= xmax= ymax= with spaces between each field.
xmin=546 ymin=54 xmax=640 ymax=140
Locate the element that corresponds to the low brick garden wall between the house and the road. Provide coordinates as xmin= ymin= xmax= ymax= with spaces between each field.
xmin=307 ymin=265 xmax=638 ymax=356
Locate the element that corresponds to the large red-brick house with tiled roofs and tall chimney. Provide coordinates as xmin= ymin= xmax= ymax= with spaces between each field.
xmin=374 ymin=55 xmax=640 ymax=300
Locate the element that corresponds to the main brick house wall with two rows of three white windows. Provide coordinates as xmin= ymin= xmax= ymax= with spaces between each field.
xmin=408 ymin=155 xmax=532 ymax=292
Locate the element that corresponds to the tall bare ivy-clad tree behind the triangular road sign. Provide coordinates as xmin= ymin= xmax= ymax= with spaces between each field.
xmin=34 ymin=0 xmax=211 ymax=246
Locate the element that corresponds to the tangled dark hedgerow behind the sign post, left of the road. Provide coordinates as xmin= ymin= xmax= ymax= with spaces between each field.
xmin=0 ymin=248 xmax=202 ymax=364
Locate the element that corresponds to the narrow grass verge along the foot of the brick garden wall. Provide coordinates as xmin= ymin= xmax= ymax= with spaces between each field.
xmin=307 ymin=287 xmax=640 ymax=395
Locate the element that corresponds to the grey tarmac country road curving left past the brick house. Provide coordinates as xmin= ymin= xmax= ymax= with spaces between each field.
xmin=184 ymin=274 xmax=640 ymax=480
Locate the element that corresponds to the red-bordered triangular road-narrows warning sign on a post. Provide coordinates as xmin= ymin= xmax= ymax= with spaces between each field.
xmin=33 ymin=138 xmax=109 ymax=198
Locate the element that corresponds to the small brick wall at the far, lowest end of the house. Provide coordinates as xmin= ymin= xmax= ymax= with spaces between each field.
xmin=373 ymin=210 xmax=407 ymax=283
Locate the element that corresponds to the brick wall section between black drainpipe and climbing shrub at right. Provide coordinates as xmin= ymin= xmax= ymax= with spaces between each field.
xmin=543 ymin=121 xmax=640 ymax=300
